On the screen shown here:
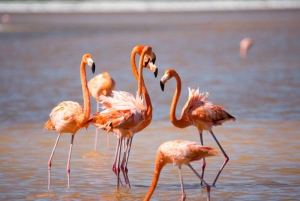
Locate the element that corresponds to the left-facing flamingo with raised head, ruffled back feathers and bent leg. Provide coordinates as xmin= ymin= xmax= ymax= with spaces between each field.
xmin=160 ymin=68 xmax=235 ymax=186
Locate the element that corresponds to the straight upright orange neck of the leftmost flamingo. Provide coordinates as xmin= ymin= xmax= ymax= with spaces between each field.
xmin=80 ymin=62 xmax=91 ymax=123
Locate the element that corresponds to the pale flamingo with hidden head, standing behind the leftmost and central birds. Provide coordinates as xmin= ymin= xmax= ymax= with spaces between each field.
xmin=88 ymin=72 xmax=116 ymax=150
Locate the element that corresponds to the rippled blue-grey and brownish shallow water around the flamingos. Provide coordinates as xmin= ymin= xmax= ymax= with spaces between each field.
xmin=0 ymin=10 xmax=300 ymax=201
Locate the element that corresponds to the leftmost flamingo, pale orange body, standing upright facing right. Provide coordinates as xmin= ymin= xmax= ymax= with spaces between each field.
xmin=44 ymin=54 xmax=95 ymax=189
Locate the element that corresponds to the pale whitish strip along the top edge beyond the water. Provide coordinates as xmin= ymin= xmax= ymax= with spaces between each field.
xmin=0 ymin=0 xmax=300 ymax=13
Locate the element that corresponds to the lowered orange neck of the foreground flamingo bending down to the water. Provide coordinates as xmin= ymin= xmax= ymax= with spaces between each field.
xmin=144 ymin=152 xmax=166 ymax=201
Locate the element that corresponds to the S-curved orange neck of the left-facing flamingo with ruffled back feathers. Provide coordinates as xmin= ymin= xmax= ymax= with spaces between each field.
xmin=170 ymin=71 xmax=189 ymax=128
